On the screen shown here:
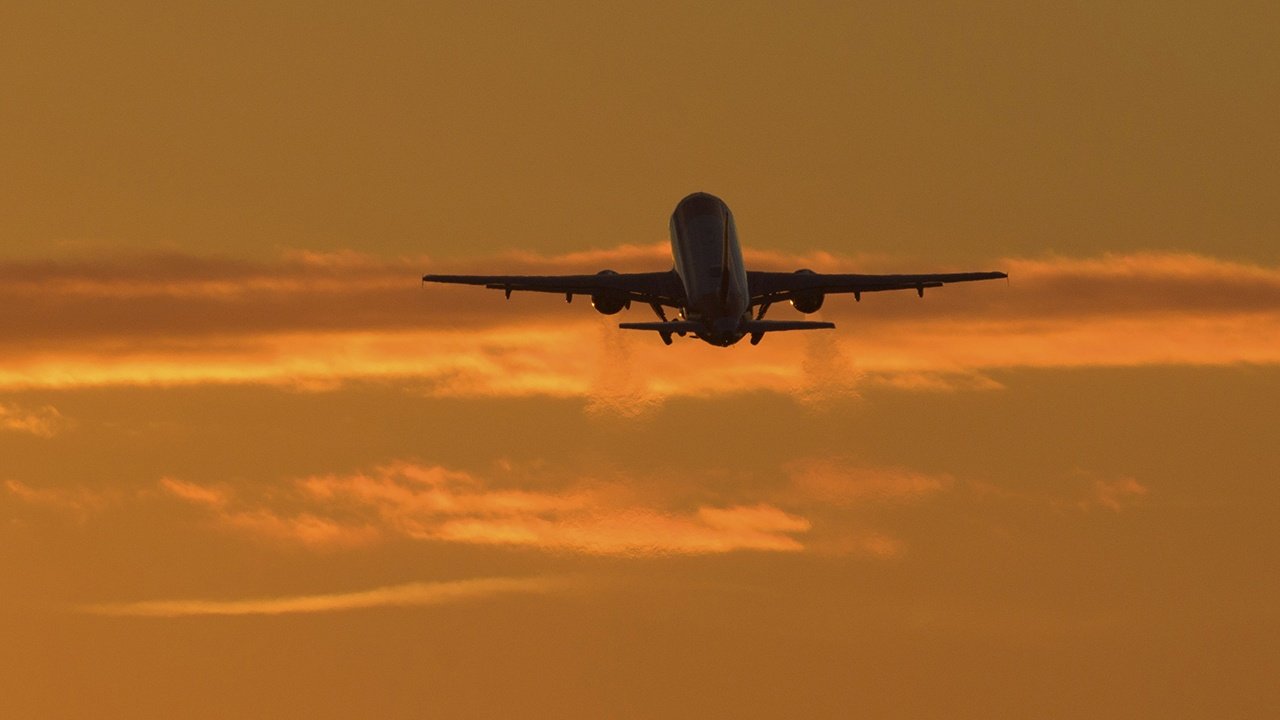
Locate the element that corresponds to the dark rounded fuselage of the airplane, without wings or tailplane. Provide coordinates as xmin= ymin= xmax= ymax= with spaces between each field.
xmin=671 ymin=192 xmax=751 ymax=347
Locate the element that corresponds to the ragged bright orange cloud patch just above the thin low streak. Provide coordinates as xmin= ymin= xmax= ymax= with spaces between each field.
xmin=161 ymin=462 xmax=810 ymax=556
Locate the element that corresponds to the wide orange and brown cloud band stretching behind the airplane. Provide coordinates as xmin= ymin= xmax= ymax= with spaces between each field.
xmin=0 ymin=245 xmax=1280 ymax=392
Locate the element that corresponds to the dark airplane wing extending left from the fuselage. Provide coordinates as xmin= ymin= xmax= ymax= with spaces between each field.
xmin=422 ymin=270 xmax=685 ymax=307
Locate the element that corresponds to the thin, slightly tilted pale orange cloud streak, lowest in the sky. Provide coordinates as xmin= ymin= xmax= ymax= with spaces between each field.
xmin=79 ymin=578 xmax=566 ymax=618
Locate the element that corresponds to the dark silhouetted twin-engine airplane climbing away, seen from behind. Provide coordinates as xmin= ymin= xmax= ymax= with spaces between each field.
xmin=422 ymin=192 xmax=1009 ymax=347
